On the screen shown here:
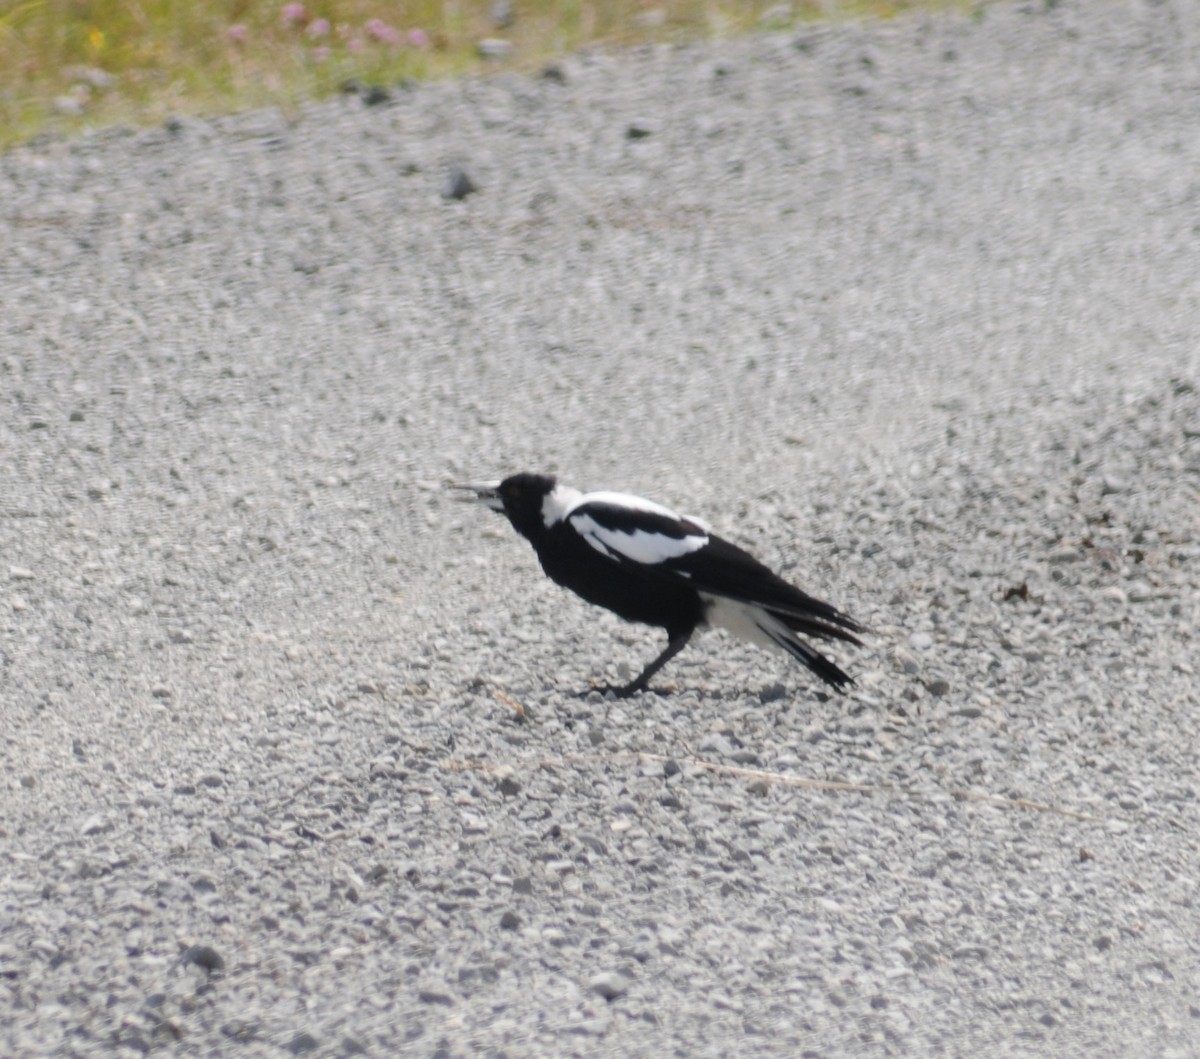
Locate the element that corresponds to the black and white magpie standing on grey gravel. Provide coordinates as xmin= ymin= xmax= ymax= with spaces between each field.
xmin=450 ymin=474 xmax=864 ymax=696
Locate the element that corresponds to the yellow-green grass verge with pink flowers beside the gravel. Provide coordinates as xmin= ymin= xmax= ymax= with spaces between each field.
xmin=0 ymin=0 xmax=962 ymax=149
